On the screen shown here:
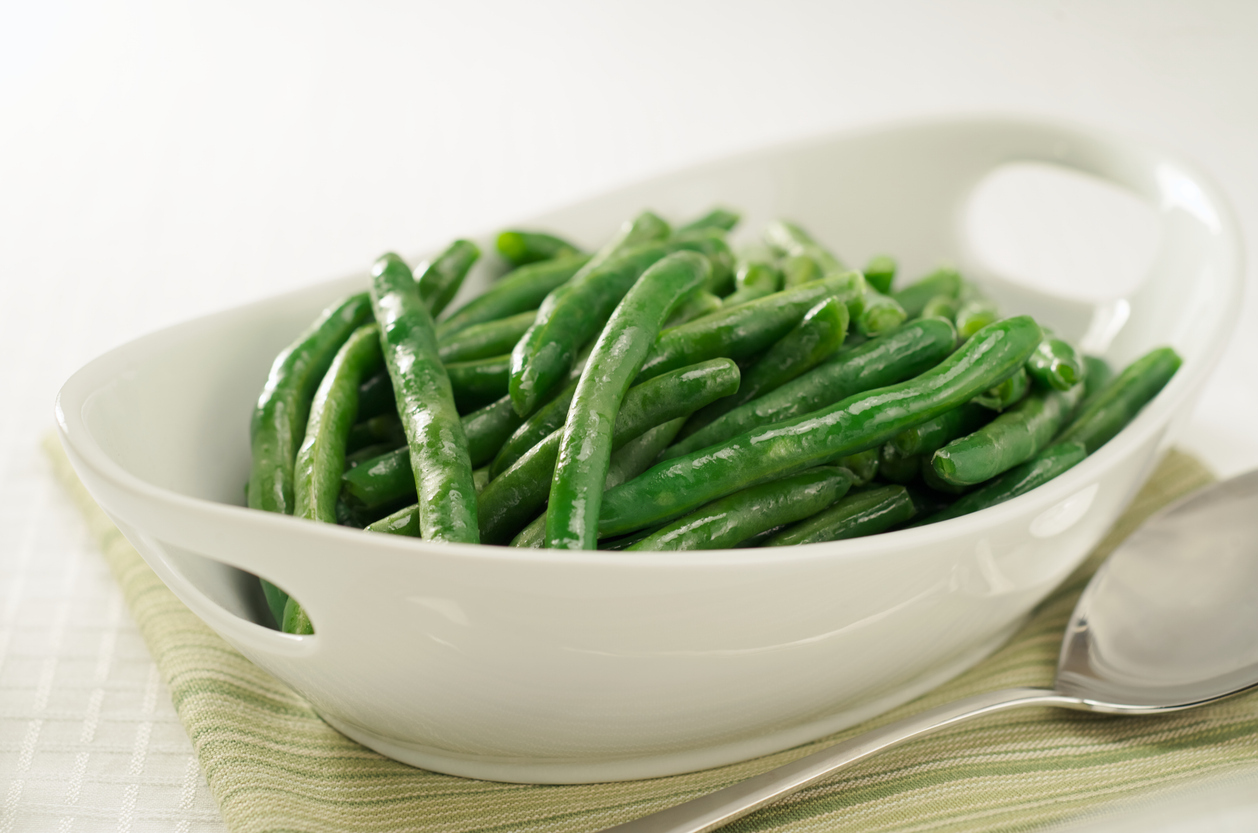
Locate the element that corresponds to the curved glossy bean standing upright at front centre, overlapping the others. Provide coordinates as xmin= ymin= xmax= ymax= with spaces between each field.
xmin=546 ymin=252 xmax=712 ymax=550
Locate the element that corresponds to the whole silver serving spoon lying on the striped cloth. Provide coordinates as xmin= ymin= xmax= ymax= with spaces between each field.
xmin=603 ymin=471 xmax=1258 ymax=833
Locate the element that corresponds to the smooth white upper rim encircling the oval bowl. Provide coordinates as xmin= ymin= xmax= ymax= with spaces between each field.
xmin=54 ymin=115 xmax=1244 ymax=570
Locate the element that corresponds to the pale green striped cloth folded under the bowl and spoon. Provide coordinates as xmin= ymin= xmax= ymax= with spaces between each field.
xmin=49 ymin=440 xmax=1258 ymax=833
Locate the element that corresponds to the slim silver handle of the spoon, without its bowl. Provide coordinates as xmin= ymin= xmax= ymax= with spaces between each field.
xmin=603 ymin=688 xmax=1082 ymax=833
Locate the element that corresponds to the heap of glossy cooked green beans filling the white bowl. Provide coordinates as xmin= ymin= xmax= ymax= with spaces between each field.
xmin=245 ymin=208 xmax=1180 ymax=633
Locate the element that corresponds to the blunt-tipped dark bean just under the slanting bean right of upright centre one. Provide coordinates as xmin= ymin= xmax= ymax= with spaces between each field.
xmin=683 ymin=297 xmax=848 ymax=435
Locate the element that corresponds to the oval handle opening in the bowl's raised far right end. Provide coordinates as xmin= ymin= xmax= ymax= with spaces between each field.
xmin=961 ymin=162 xmax=1161 ymax=302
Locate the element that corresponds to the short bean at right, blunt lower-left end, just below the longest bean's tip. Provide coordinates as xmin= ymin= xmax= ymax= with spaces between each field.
xmin=931 ymin=385 xmax=1083 ymax=486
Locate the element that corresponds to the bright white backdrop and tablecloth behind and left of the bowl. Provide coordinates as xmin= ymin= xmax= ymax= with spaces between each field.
xmin=0 ymin=0 xmax=1258 ymax=833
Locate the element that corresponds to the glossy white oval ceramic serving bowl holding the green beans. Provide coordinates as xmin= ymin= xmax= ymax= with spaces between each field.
xmin=58 ymin=118 xmax=1242 ymax=783
